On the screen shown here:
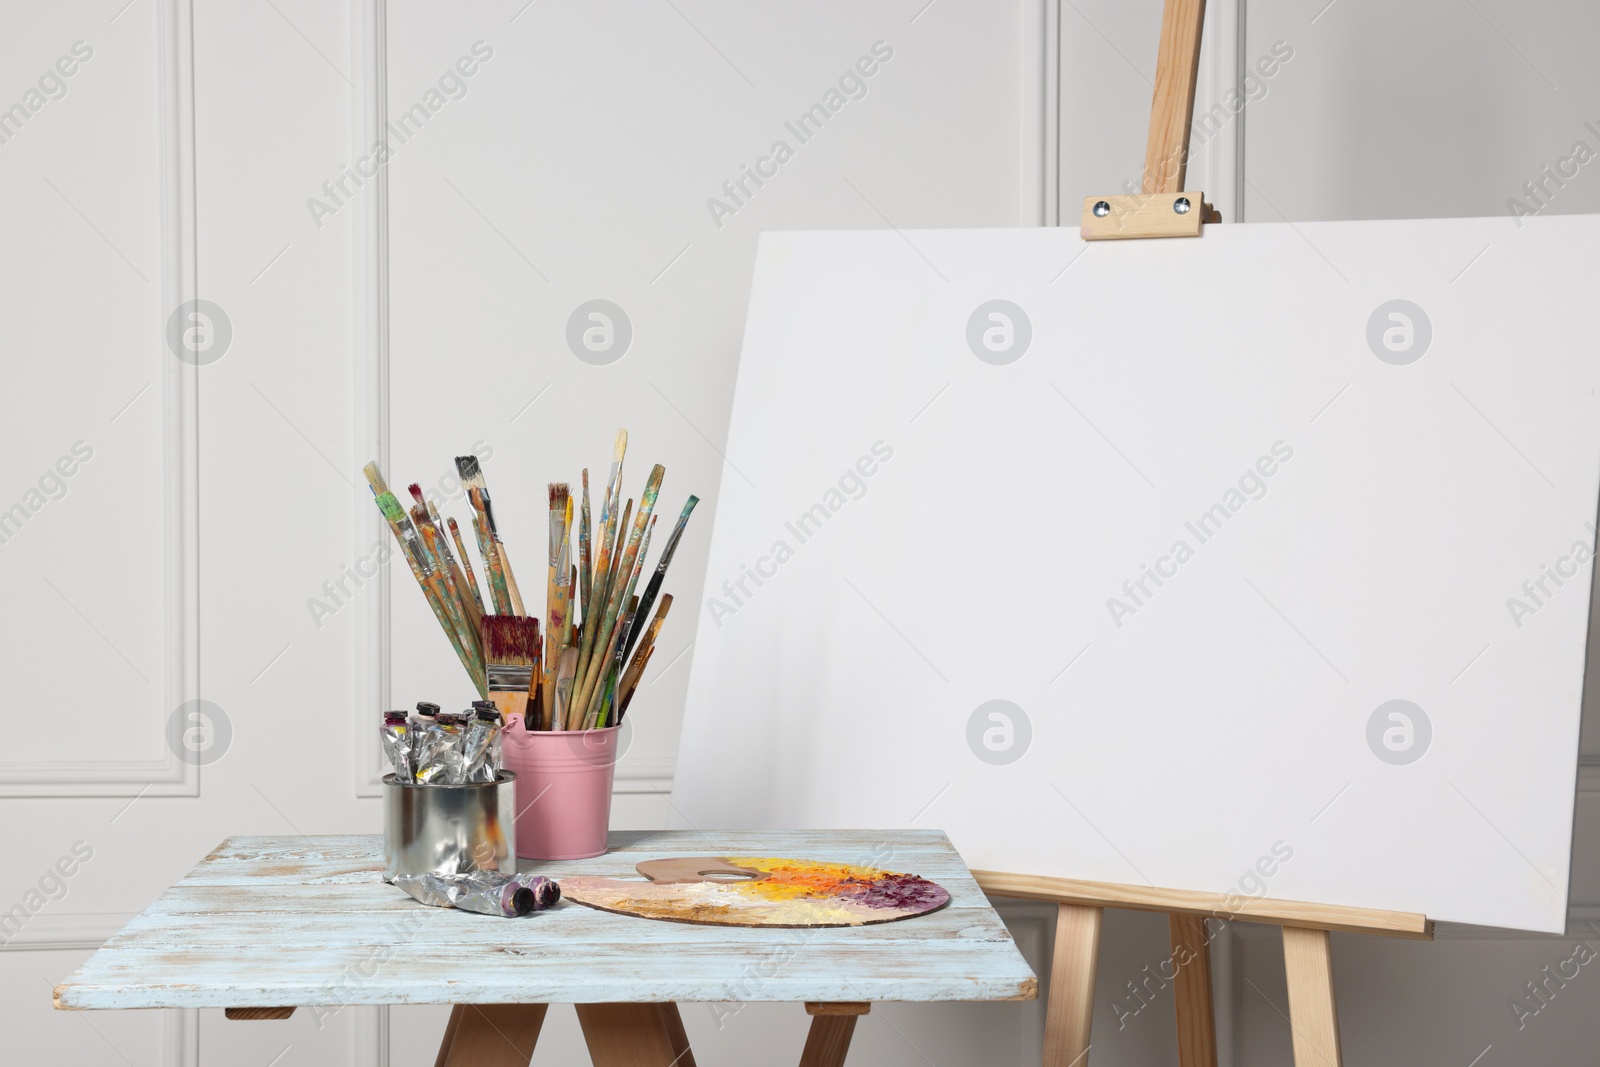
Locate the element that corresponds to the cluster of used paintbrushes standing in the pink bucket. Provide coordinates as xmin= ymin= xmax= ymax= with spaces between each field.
xmin=366 ymin=430 xmax=699 ymax=729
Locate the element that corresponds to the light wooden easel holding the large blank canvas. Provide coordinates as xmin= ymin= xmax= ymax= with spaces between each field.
xmin=973 ymin=0 xmax=1434 ymax=1067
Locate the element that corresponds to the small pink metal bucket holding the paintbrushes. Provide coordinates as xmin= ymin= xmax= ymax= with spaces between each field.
xmin=501 ymin=717 xmax=621 ymax=859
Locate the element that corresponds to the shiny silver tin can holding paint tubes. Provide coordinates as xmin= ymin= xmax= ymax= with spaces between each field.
xmin=384 ymin=771 xmax=517 ymax=881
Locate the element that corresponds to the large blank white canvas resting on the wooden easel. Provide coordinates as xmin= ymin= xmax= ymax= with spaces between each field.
xmin=672 ymin=216 xmax=1600 ymax=931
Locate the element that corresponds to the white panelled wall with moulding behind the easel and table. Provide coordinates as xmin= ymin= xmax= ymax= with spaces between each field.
xmin=0 ymin=0 xmax=1600 ymax=1067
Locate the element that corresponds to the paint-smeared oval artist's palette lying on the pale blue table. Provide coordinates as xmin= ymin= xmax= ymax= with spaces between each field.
xmin=560 ymin=856 xmax=950 ymax=926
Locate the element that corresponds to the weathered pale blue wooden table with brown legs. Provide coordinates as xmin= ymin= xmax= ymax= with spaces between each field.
xmin=56 ymin=830 xmax=1037 ymax=1067
